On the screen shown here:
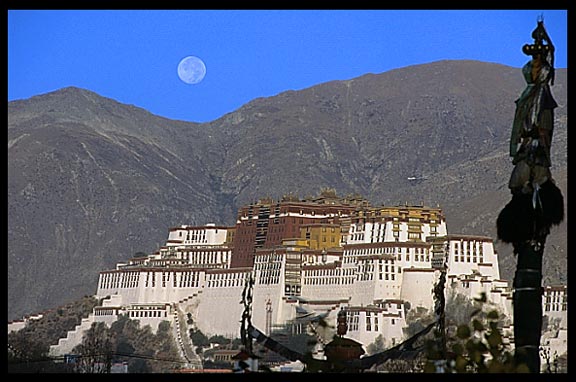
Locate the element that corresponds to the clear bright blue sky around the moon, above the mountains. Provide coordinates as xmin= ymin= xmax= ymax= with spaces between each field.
xmin=8 ymin=10 xmax=568 ymax=122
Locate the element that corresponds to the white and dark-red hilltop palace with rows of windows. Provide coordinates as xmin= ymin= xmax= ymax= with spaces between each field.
xmin=9 ymin=190 xmax=567 ymax=367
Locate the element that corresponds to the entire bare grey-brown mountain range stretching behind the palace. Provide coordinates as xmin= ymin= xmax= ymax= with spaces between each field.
xmin=8 ymin=61 xmax=567 ymax=319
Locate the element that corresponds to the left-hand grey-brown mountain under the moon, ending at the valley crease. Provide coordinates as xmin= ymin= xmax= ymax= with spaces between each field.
xmin=8 ymin=88 xmax=230 ymax=317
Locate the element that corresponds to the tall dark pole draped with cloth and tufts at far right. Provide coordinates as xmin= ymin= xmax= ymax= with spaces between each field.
xmin=496 ymin=18 xmax=564 ymax=373
